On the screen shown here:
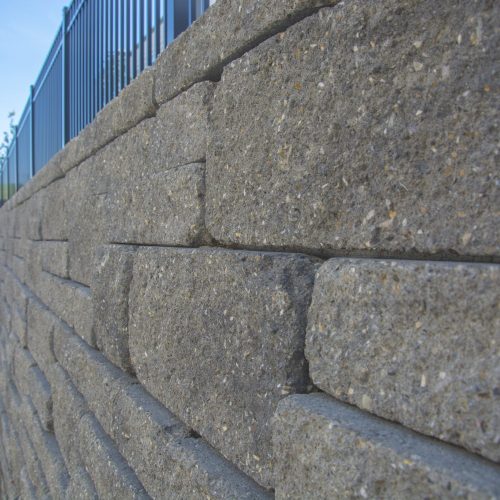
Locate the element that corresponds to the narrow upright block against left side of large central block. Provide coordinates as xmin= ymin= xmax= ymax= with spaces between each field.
xmin=92 ymin=246 xmax=136 ymax=371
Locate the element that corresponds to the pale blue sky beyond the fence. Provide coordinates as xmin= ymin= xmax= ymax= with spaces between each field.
xmin=0 ymin=0 xmax=70 ymax=139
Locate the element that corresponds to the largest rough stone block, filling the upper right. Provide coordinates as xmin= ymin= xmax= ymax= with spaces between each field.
xmin=206 ymin=0 xmax=500 ymax=258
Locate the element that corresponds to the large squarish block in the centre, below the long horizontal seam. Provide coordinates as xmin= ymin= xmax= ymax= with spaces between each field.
xmin=129 ymin=248 xmax=315 ymax=486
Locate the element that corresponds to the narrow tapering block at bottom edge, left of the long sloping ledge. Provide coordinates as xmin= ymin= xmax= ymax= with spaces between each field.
xmin=79 ymin=414 xmax=150 ymax=499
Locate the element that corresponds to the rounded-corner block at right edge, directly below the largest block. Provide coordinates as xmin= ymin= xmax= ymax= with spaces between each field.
xmin=306 ymin=259 xmax=500 ymax=461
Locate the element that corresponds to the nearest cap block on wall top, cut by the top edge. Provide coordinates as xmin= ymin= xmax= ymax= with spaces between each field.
xmin=155 ymin=0 xmax=338 ymax=104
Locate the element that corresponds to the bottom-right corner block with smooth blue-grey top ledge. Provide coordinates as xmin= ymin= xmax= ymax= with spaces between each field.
xmin=273 ymin=394 xmax=500 ymax=500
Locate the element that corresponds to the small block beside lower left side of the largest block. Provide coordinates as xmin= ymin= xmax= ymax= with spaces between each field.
xmin=105 ymin=164 xmax=205 ymax=246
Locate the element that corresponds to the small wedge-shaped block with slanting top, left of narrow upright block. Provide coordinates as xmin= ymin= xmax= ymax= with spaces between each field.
xmin=39 ymin=272 xmax=95 ymax=346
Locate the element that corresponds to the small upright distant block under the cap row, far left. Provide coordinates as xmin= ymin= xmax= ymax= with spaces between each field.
xmin=42 ymin=179 xmax=73 ymax=240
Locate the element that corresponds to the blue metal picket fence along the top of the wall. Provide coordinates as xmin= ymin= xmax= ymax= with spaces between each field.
xmin=0 ymin=0 xmax=214 ymax=204
